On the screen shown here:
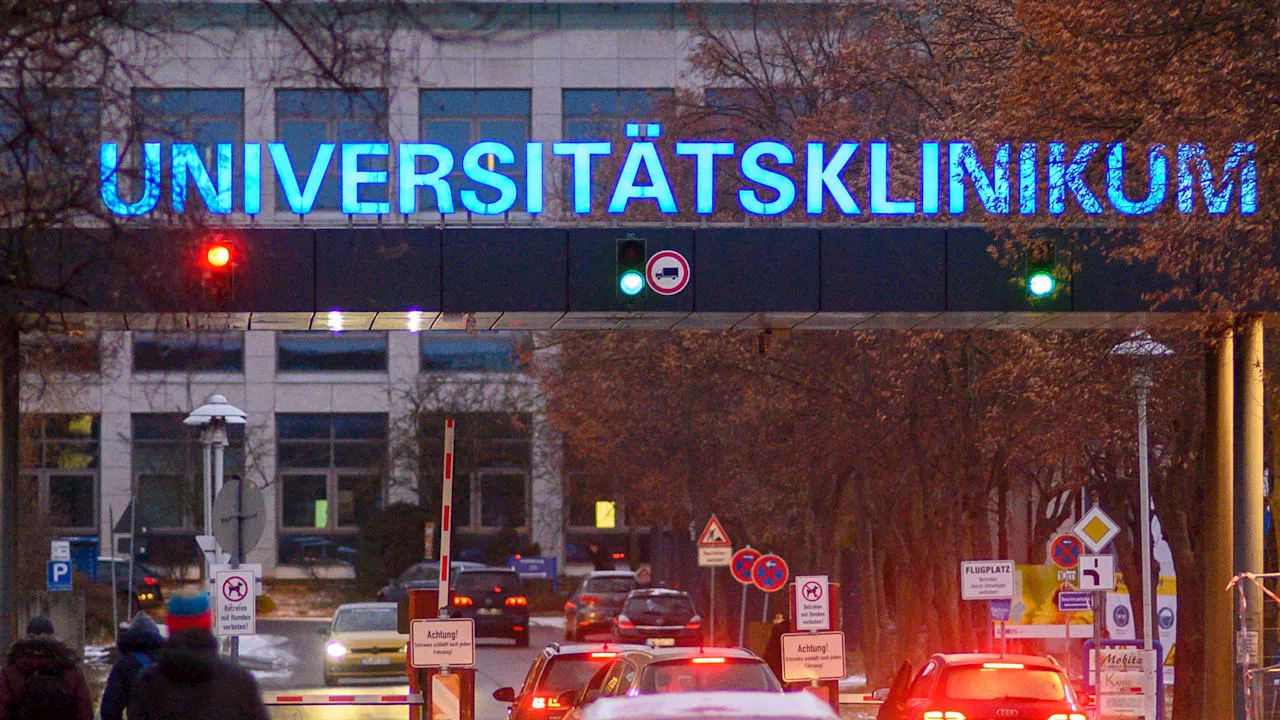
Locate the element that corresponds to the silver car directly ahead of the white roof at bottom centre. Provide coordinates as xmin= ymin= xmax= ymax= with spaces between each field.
xmin=561 ymin=647 xmax=782 ymax=720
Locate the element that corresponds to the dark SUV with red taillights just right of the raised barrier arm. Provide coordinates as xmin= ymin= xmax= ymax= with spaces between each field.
xmin=445 ymin=565 xmax=529 ymax=647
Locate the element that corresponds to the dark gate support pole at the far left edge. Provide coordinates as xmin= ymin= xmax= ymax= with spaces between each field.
xmin=0 ymin=320 xmax=22 ymax=652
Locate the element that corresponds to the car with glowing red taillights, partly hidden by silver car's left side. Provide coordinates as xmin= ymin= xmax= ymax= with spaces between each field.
xmin=493 ymin=643 xmax=641 ymax=720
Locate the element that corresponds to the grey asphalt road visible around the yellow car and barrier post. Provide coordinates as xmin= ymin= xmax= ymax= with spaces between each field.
xmin=257 ymin=620 xmax=559 ymax=720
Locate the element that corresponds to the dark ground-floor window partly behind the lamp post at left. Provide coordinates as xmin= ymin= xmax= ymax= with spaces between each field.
xmin=133 ymin=413 xmax=244 ymax=533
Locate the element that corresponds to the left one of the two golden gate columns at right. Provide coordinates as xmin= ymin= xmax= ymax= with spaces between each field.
xmin=1202 ymin=325 xmax=1235 ymax=717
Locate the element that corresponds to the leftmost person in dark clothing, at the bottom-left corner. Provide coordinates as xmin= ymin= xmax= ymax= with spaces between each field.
xmin=0 ymin=615 xmax=93 ymax=720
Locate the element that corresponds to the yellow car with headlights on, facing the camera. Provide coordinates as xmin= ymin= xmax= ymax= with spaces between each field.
xmin=320 ymin=602 xmax=408 ymax=685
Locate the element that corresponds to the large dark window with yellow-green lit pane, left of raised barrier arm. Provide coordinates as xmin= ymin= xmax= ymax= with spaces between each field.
xmin=275 ymin=413 xmax=388 ymax=562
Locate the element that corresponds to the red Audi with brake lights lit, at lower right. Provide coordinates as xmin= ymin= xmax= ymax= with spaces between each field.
xmin=877 ymin=653 xmax=1087 ymax=720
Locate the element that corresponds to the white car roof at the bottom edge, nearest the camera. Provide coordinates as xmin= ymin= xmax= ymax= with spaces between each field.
xmin=582 ymin=692 xmax=840 ymax=720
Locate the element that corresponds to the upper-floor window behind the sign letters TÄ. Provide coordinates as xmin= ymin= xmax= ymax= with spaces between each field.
xmin=562 ymin=90 xmax=675 ymax=209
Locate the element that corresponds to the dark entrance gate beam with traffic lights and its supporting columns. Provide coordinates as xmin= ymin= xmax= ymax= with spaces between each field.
xmin=0 ymin=223 xmax=1277 ymax=717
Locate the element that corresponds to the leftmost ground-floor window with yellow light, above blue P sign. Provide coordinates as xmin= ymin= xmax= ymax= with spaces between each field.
xmin=22 ymin=414 xmax=101 ymax=533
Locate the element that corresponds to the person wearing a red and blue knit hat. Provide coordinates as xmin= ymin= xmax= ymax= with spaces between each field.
xmin=129 ymin=592 xmax=268 ymax=720
